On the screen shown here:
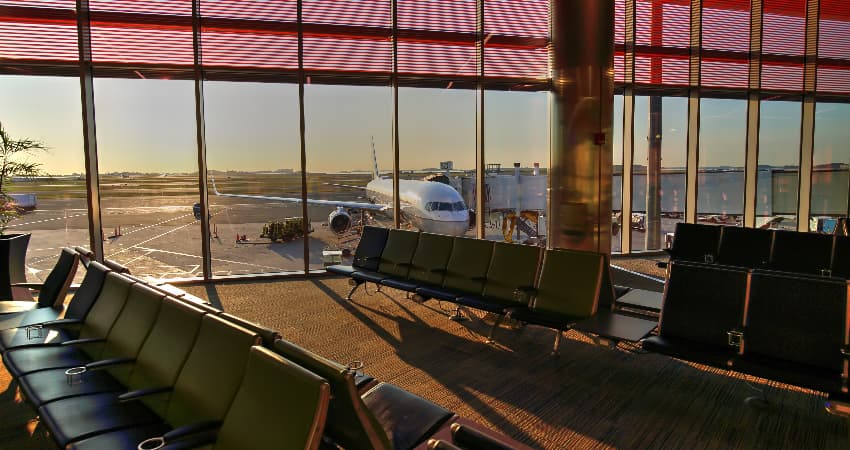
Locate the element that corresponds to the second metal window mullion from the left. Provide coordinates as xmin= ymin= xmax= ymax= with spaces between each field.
xmin=192 ymin=0 xmax=212 ymax=280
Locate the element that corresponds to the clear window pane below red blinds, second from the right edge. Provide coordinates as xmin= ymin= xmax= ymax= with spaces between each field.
xmin=756 ymin=100 xmax=803 ymax=230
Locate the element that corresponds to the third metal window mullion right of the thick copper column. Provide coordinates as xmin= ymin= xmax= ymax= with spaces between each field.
xmin=744 ymin=0 xmax=763 ymax=228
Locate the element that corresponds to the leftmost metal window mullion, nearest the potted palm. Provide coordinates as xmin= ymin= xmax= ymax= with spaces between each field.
xmin=77 ymin=0 xmax=105 ymax=261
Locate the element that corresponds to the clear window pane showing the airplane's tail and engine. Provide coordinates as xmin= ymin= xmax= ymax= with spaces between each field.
xmin=304 ymin=84 xmax=393 ymax=269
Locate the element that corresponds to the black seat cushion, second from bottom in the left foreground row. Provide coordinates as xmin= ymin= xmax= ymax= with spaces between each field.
xmin=38 ymin=393 xmax=162 ymax=447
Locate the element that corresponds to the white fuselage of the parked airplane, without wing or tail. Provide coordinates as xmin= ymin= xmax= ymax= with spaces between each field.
xmin=366 ymin=178 xmax=469 ymax=236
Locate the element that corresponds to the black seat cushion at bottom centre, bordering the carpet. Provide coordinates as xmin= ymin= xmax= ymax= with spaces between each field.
xmin=363 ymin=383 xmax=454 ymax=449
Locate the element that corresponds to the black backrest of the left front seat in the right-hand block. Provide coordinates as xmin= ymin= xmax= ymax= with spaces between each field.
xmin=660 ymin=261 xmax=749 ymax=347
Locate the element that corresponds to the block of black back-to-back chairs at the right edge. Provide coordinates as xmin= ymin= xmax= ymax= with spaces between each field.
xmin=643 ymin=224 xmax=850 ymax=401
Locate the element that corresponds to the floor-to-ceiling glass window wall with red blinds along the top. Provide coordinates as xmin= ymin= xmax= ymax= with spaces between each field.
xmin=0 ymin=0 xmax=850 ymax=278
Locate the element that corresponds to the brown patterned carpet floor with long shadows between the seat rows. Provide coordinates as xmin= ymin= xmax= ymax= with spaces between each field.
xmin=0 ymin=278 xmax=850 ymax=449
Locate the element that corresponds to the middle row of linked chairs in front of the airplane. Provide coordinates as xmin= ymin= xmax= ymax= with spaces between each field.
xmin=327 ymin=226 xmax=615 ymax=353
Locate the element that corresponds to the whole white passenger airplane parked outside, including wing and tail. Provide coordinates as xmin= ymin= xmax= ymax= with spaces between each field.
xmin=212 ymin=142 xmax=469 ymax=236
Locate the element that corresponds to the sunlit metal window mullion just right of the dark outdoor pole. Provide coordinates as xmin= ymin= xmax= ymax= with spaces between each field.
xmin=685 ymin=0 xmax=702 ymax=223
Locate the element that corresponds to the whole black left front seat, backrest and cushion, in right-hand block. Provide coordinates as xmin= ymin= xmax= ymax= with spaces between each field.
xmin=643 ymin=261 xmax=749 ymax=368
